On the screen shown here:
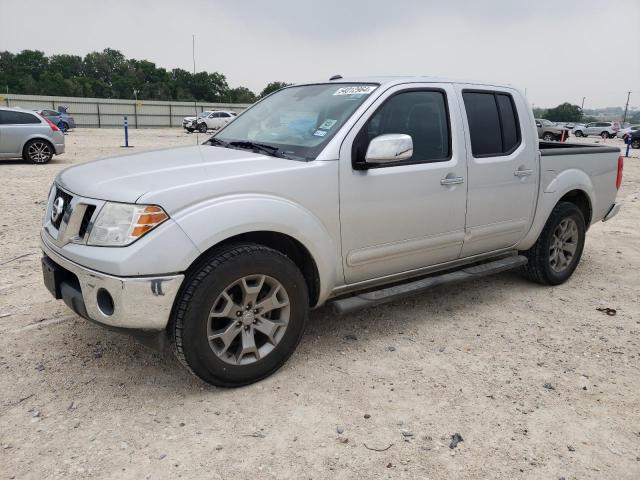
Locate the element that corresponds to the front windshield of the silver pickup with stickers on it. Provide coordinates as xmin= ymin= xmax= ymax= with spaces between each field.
xmin=209 ymin=83 xmax=378 ymax=161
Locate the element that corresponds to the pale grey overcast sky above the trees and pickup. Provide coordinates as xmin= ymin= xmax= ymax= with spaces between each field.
xmin=0 ymin=0 xmax=640 ymax=108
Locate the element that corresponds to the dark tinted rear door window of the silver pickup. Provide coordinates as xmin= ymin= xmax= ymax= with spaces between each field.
xmin=462 ymin=91 xmax=521 ymax=157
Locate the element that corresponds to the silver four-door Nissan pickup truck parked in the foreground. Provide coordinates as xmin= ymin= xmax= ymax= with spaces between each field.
xmin=41 ymin=77 xmax=622 ymax=386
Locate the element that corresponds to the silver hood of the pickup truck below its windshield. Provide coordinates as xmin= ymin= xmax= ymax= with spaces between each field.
xmin=56 ymin=145 xmax=307 ymax=205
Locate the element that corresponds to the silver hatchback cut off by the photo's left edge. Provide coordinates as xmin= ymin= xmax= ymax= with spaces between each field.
xmin=0 ymin=107 xmax=64 ymax=163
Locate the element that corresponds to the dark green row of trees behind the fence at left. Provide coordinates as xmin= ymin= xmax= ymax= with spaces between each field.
xmin=0 ymin=48 xmax=288 ymax=103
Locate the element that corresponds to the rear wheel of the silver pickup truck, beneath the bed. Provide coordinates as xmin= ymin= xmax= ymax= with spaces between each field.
xmin=522 ymin=202 xmax=586 ymax=285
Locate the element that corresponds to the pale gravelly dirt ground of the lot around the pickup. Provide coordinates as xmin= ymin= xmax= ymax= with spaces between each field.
xmin=0 ymin=129 xmax=640 ymax=479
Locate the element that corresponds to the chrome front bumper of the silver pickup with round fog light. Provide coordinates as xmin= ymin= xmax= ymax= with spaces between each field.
xmin=40 ymin=235 xmax=184 ymax=330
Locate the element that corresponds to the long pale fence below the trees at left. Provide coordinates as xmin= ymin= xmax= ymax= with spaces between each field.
xmin=0 ymin=93 xmax=249 ymax=128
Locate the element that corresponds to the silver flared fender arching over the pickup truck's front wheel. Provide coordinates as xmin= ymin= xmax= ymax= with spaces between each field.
xmin=174 ymin=194 xmax=341 ymax=303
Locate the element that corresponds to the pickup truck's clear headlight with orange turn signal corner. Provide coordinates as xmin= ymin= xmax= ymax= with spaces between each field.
xmin=87 ymin=202 xmax=169 ymax=247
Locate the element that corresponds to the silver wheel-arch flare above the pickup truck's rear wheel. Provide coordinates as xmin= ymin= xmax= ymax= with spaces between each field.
xmin=516 ymin=169 xmax=596 ymax=250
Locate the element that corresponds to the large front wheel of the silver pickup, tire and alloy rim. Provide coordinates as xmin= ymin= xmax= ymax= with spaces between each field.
xmin=169 ymin=244 xmax=309 ymax=387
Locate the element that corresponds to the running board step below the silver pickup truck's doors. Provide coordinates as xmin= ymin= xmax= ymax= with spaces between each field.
xmin=331 ymin=255 xmax=527 ymax=314
